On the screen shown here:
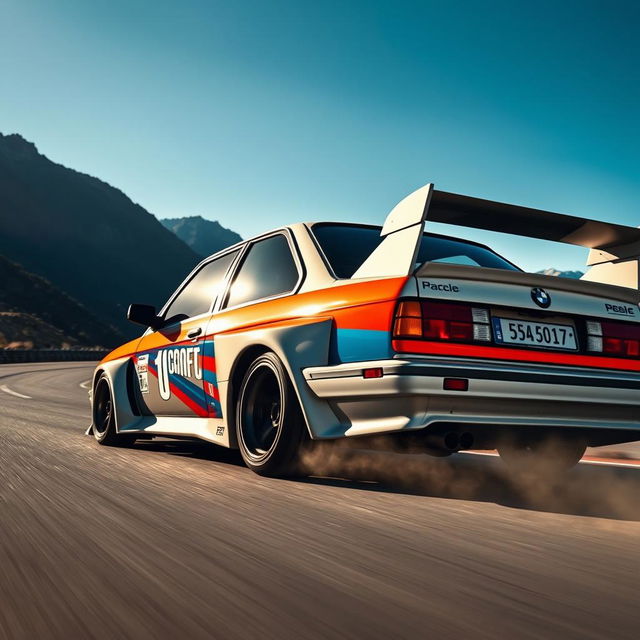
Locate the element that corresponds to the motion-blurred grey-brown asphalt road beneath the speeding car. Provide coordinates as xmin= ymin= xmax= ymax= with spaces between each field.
xmin=0 ymin=363 xmax=640 ymax=640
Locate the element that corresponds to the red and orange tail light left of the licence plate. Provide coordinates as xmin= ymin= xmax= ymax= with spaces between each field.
xmin=393 ymin=300 xmax=491 ymax=342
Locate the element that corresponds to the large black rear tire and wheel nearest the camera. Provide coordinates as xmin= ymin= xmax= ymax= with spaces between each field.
xmin=236 ymin=352 xmax=306 ymax=477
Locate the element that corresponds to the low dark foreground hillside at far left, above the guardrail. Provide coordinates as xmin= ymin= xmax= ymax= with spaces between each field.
xmin=0 ymin=256 xmax=124 ymax=346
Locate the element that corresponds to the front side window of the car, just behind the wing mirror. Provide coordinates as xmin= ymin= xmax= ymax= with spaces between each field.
xmin=164 ymin=250 xmax=239 ymax=322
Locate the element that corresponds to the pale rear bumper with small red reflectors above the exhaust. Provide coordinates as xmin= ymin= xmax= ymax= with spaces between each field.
xmin=303 ymin=356 xmax=640 ymax=436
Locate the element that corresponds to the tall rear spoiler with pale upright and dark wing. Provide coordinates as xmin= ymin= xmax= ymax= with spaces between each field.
xmin=353 ymin=184 xmax=640 ymax=284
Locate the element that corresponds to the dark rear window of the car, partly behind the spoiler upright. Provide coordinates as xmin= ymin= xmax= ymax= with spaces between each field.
xmin=312 ymin=224 xmax=519 ymax=278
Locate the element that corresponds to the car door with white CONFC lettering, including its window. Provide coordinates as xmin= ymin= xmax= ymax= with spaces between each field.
xmin=135 ymin=249 xmax=240 ymax=417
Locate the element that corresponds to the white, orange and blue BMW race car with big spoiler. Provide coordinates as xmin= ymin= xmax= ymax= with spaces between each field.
xmin=89 ymin=184 xmax=640 ymax=476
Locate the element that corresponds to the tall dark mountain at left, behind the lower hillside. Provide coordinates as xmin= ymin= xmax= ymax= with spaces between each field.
xmin=0 ymin=134 xmax=200 ymax=337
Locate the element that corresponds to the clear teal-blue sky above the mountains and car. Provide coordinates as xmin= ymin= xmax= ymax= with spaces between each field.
xmin=0 ymin=0 xmax=640 ymax=270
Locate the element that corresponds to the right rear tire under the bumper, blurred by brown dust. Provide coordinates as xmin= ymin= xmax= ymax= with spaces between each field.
xmin=498 ymin=435 xmax=587 ymax=477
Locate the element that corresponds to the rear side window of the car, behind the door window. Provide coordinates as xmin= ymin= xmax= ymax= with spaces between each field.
xmin=225 ymin=234 xmax=299 ymax=307
